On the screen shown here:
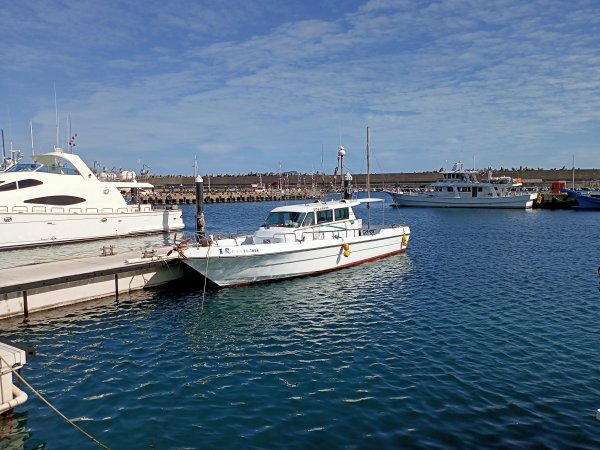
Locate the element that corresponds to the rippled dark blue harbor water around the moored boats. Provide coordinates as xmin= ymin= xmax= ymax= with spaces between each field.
xmin=0 ymin=199 xmax=600 ymax=449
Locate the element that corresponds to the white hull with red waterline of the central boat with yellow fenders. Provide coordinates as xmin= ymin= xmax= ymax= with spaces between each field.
xmin=182 ymin=226 xmax=410 ymax=287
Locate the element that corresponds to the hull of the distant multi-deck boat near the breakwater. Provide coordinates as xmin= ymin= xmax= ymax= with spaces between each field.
xmin=388 ymin=191 xmax=537 ymax=209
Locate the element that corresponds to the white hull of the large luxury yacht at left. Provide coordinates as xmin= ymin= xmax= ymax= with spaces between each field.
xmin=0 ymin=207 xmax=184 ymax=250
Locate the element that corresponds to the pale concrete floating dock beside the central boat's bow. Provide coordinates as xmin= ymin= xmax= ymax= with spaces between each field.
xmin=0 ymin=247 xmax=184 ymax=319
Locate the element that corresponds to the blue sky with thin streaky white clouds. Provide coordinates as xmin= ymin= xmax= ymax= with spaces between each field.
xmin=0 ymin=0 xmax=600 ymax=175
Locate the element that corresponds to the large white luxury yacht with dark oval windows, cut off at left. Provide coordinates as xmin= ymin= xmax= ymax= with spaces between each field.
xmin=0 ymin=148 xmax=184 ymax=250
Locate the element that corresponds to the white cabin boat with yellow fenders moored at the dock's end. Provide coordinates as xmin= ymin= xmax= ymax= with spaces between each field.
xmin=176 ymin=198 xmax=410 ymax=287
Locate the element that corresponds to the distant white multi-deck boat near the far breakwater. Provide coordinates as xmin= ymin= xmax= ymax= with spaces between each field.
xmin=385 ymin=161 xmax=537 ymax=209
